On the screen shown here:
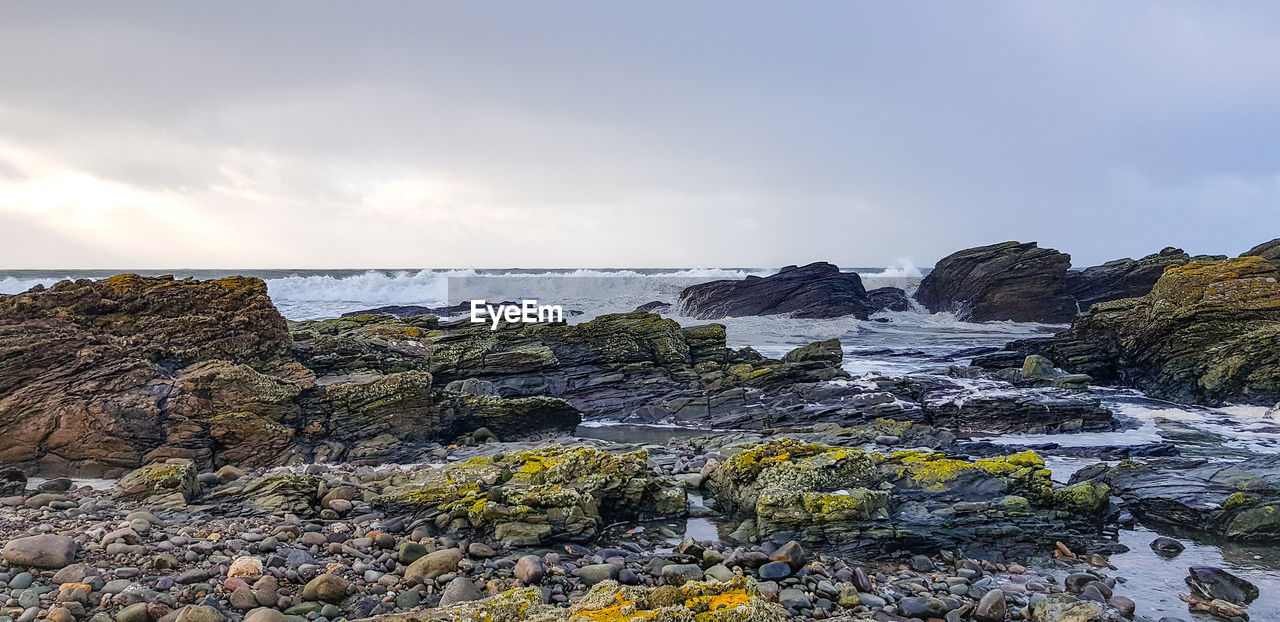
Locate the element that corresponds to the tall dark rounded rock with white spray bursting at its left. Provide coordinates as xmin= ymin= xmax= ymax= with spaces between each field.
xmin=915 ymin=242 xmax=1076 ymax=323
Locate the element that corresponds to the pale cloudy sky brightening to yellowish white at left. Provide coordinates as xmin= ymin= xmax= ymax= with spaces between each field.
xmin=0 ymin=0 xmax=1280 ymax=269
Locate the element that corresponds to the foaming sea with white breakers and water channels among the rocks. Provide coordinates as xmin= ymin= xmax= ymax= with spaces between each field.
xmin=0 ymin=260 xmax=1280 ymax=619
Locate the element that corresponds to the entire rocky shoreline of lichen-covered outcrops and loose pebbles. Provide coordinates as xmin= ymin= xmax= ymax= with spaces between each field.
xmin=0 ymin=243 xmax=1280 ymax=622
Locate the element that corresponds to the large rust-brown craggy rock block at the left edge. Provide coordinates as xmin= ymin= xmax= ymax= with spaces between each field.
xmin=0 ymin=274 xmax=294 ymax=475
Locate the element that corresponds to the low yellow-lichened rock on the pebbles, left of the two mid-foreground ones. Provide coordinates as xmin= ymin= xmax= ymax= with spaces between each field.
xmin=372 ymin=445 xmax=686 ymax=544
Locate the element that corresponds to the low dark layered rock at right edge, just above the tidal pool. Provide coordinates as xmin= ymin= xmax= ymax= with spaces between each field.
xmin=1071 ymin=456 xmax=1280 ymax=541
